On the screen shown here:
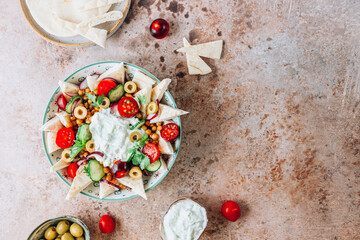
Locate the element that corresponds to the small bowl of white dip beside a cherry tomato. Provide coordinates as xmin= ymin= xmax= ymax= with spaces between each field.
xmin=160 ymin=198 xmax=208 ymax=240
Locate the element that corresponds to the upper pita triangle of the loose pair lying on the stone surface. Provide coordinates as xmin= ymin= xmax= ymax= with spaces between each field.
xmin=177 ymin=40 xmax=223 ymax=59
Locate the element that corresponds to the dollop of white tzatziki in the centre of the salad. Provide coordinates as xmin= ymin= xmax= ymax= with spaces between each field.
xmin=90 ymin=109 xmax=141 ymax=167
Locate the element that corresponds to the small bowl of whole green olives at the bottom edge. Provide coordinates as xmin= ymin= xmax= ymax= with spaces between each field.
xmin=28 ymin=216 xmax=90 ymax=240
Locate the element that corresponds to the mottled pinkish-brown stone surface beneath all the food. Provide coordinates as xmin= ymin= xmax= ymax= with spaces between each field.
xmin=0 ymin=0 xmax=360 ymax=240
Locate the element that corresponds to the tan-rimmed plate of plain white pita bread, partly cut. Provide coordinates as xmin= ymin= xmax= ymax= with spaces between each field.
xmin=20 ymin=0 xmax=131 ymax=47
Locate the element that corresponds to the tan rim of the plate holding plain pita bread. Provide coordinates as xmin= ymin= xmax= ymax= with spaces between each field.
xmin=19 ymin=0 xmax=131 ymax=47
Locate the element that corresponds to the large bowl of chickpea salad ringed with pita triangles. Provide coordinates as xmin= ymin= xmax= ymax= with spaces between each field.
xmin=40 ymin=61 xmax=188 ymax=201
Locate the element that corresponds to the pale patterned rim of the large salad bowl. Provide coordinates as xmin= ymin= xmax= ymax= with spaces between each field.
xmin=42 ymin=61 xmax=182 ymax=202
